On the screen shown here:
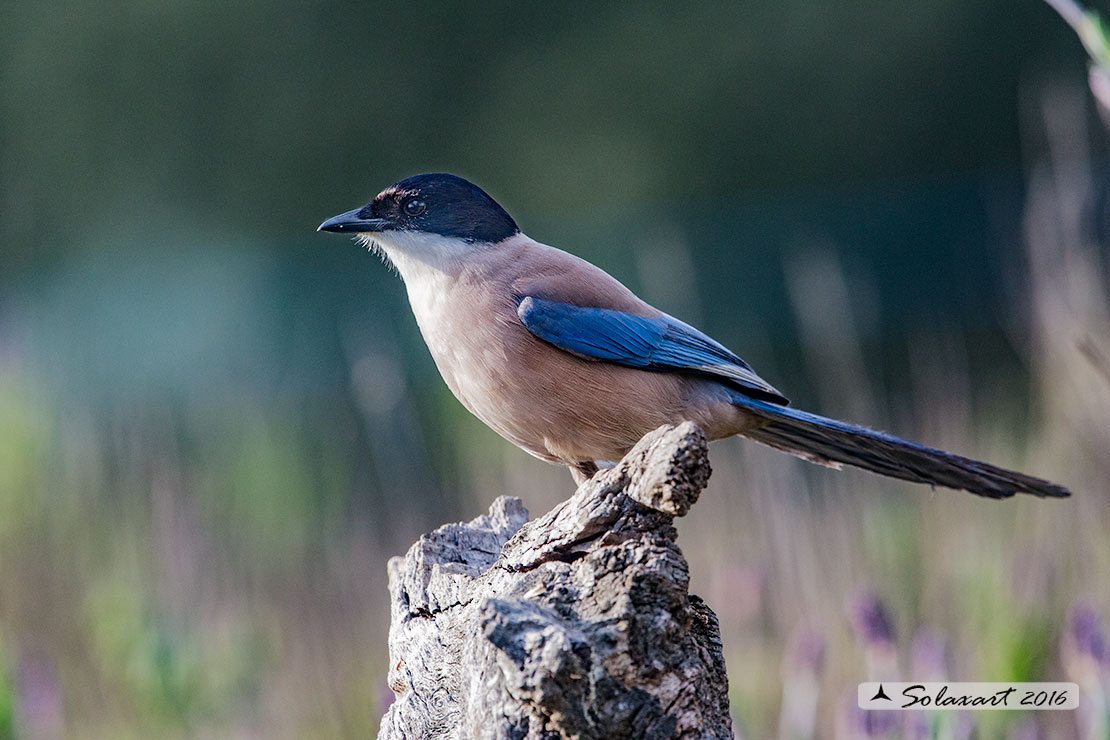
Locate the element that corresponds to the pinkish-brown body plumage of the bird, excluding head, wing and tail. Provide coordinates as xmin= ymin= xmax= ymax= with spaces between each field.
xmin=412 ymin=234 xmax=748 ymax=464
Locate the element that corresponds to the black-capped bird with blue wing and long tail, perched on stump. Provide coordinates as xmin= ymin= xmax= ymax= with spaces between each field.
xmin=316 ymin=173 xmax=1070 ymax=498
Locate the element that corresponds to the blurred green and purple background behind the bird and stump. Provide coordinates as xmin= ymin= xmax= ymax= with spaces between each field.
xmin=0 ymin=0 xmax=1110 ymax=739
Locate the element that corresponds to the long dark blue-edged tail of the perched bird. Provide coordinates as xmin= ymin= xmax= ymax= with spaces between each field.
xmin=734 ymin=394 xmax=1071 ymax=498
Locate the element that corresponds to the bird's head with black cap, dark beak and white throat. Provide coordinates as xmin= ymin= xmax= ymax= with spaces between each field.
xmin=316 ymin=173 xmax=519 ymax=266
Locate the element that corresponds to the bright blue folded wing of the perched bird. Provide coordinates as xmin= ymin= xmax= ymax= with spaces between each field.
xmin=516 ymin=295 xmax=789 ymax=404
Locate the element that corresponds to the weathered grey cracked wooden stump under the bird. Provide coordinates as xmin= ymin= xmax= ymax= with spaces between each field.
xmin=379 ymin=424 xmax=733 ymax=740
